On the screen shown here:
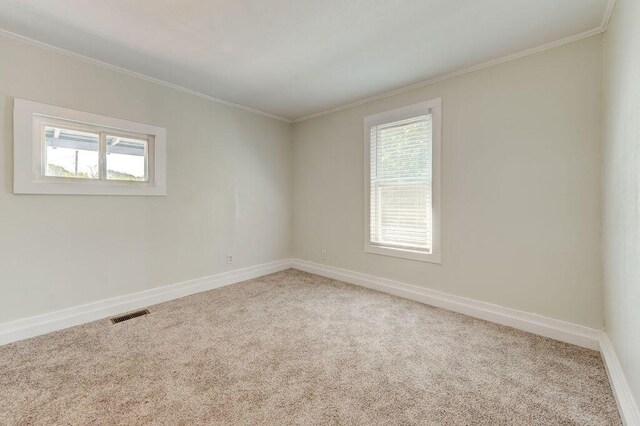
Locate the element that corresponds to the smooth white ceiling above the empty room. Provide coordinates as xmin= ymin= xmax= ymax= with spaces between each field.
xmin=0 ymin=0 xmax=609 ymax=119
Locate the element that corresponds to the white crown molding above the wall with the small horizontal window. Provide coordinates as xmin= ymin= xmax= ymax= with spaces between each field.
xmin=0 ymin=28 xmax=291 ymax=124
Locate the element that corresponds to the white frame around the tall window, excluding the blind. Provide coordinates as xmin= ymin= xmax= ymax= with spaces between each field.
xmin=364 ymin=98 xmax=442 ymax=263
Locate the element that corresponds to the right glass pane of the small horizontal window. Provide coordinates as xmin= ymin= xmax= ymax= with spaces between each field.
xmin=107 ymin=135 xmax=147 ymax=181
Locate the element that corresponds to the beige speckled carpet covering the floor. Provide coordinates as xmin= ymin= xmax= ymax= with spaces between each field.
xmin=0 ymin=270 xmax=620 ymax=425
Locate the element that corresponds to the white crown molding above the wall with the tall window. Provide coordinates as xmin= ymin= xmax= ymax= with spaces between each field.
xmin=292 ymin=26 xmax=615 ymax=124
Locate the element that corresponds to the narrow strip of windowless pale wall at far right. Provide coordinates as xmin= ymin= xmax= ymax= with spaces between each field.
xmin=602 ymin=0 xmax=640 ymax=406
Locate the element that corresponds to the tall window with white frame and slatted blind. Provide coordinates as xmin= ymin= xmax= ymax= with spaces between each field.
xmin=365 ymin=99 xmax=441 ymax=262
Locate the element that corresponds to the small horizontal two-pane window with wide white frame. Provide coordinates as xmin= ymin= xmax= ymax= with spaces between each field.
xmin=14 ymin=99 xmax=165 ymax=195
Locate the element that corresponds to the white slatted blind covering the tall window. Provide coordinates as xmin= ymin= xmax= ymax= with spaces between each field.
xmin=369 ymin=113 xmax=433 ymax=253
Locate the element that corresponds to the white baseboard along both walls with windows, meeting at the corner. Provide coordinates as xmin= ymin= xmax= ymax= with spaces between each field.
xmin=0 ymin=259 xmax=601 ymax=350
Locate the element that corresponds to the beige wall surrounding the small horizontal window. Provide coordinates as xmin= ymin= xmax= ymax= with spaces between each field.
xmin=0 ymin=37 xmax=292 ymax=323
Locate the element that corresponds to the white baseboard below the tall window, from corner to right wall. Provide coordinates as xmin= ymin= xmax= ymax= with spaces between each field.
xmin=292 ymin=259 xmax=602 ymax=350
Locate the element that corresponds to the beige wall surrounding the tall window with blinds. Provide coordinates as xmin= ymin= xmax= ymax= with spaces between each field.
xmin=293 ymin=36 xmax=603 ymax=328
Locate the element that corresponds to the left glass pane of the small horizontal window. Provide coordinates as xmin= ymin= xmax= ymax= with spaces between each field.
xmin=44 ymin=125 xmax=100 ymax=179
